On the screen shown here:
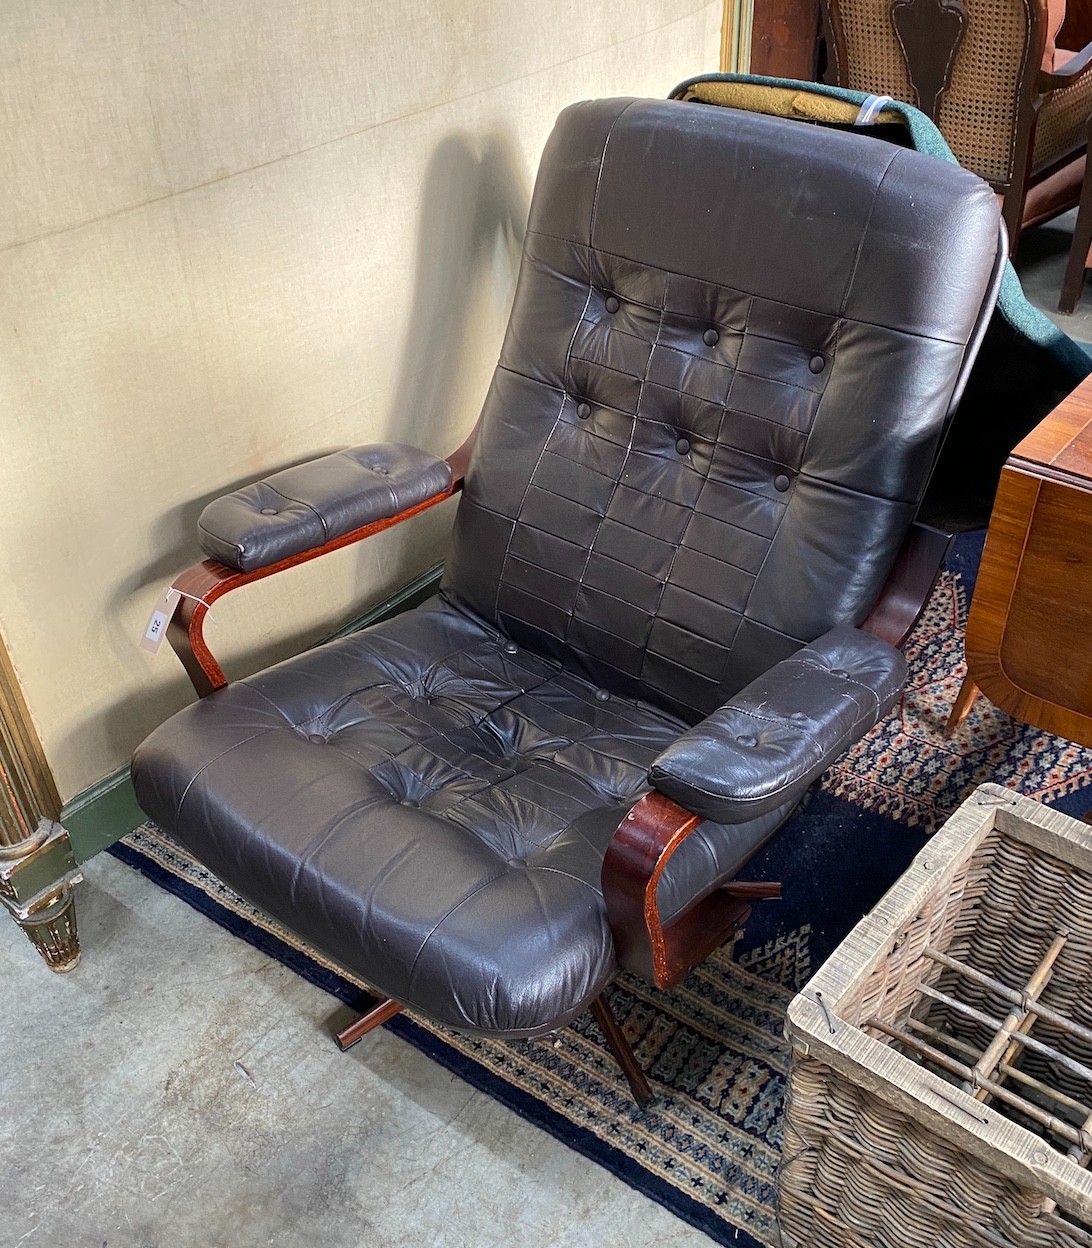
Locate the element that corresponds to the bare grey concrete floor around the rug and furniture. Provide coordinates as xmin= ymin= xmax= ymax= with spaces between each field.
xmin=0 ymin=215 xmax=1092 ymax=1248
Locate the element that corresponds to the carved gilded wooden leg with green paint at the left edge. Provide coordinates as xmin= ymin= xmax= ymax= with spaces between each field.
xmin=0 ymin=628 xmax=81 ymax=971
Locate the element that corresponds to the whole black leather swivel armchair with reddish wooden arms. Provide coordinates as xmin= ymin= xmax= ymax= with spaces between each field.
xmin=134 ymin=100 xmax=1005 ymax=1099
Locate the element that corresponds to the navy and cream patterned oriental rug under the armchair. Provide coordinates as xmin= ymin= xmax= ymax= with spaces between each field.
xmin=111 ymin=551 xmax=1092 ymax=1248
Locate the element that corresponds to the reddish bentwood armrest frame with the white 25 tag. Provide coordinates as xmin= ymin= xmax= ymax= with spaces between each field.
xmin=167 ymin=426 xmax=478 ymax=698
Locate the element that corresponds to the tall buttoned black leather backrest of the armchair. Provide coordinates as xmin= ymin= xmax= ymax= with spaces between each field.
xmin=444 ymin=100 xmax=998 ymax=720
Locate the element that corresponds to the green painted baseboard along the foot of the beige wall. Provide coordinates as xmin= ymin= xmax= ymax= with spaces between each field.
xmin=60 ymin=564 xmax=442 ymax=862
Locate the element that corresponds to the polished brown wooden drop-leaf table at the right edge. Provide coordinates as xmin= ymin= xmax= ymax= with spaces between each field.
xmin=948 ymin=377 xmax=1092 ymax=746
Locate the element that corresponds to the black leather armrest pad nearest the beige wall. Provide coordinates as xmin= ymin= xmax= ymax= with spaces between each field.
xmin=197 ymin=443 xmax=452 ymax=572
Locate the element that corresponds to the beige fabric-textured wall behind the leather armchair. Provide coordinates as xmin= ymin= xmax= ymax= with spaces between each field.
xmin=0 ymin=0 xmax=721 ymax=799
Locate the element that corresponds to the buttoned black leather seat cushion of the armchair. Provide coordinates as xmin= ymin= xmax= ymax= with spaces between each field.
xmin=139 ymin=599 xmax=786 ymax=1036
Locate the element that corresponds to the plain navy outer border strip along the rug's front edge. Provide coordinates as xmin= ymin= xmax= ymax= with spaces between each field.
xmin=106 ymin=833 xmax=763 ymax=1248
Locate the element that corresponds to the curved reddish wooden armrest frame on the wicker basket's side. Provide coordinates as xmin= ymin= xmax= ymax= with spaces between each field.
xmin=603 ymin=790 xmax=781 ymax=988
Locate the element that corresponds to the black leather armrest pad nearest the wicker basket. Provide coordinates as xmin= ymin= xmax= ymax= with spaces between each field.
xmin=649 ymin=625 xmax=906 ymax=824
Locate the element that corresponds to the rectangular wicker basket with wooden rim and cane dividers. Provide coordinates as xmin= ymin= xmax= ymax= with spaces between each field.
xmin=780 ymin=785 xmax=1092 ymax=1248
